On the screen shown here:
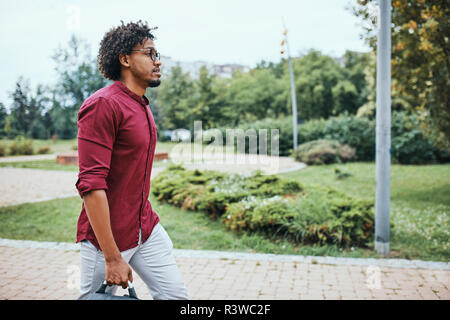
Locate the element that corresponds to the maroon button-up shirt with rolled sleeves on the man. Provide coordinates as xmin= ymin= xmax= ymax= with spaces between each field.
xmin=76 ymin=81 xmax=159 ymax=251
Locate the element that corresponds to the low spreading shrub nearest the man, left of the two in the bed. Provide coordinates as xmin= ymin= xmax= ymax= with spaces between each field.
xmin=152 ymin=165 xmax=302 ymax=217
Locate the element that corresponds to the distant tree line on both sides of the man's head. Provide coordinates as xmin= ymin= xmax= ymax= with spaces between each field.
xmin=0 ymin=37 xmax=371 ymax=139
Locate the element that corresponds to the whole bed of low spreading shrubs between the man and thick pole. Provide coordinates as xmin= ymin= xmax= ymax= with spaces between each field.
xmin=152 ymin=166 xmax=374 ymax=246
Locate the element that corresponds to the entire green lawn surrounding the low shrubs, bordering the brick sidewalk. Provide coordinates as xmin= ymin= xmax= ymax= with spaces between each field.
xmin=0 ymin=163 xmax=450 ymax=261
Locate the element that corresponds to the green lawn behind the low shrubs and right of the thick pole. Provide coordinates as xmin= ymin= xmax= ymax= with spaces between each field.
xmin=280 ymin=163 xmax=450 ymax=261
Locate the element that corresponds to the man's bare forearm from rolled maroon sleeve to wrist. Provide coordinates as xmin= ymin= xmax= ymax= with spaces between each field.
xmin=83 ymin=190 xmax=122 ymax=262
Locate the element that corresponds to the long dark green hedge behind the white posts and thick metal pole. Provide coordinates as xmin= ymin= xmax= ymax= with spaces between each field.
xmin=216 ymin=111 xmax=450 ymax=164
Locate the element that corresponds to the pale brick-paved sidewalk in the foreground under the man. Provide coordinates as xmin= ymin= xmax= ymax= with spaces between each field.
xmin=0 ymin=239 xmax=450 ymax=300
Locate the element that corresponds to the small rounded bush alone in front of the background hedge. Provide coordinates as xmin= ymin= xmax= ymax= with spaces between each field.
xmin=294 ymin=140 xmax=356 ymax=165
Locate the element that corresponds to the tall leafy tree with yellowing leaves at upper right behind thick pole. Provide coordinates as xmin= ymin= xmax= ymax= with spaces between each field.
xmin=352 ymin=0 xmax=450 ymax=148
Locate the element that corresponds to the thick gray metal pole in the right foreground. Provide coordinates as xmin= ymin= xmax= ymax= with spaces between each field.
xmin=375 ymin=0 xmax=391 ymax=256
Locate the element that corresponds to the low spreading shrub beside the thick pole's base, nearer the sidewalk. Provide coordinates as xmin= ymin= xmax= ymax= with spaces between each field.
xmin=224 ymin=187 xmax=374 ymax=247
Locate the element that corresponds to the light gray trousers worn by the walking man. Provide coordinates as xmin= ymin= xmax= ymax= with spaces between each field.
xmin=79 ymin=223 xmax=189 ymax=300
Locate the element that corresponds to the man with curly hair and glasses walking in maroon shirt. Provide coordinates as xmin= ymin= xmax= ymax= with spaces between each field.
xmin=76 ymin=21 xmax=188 ymax=299
